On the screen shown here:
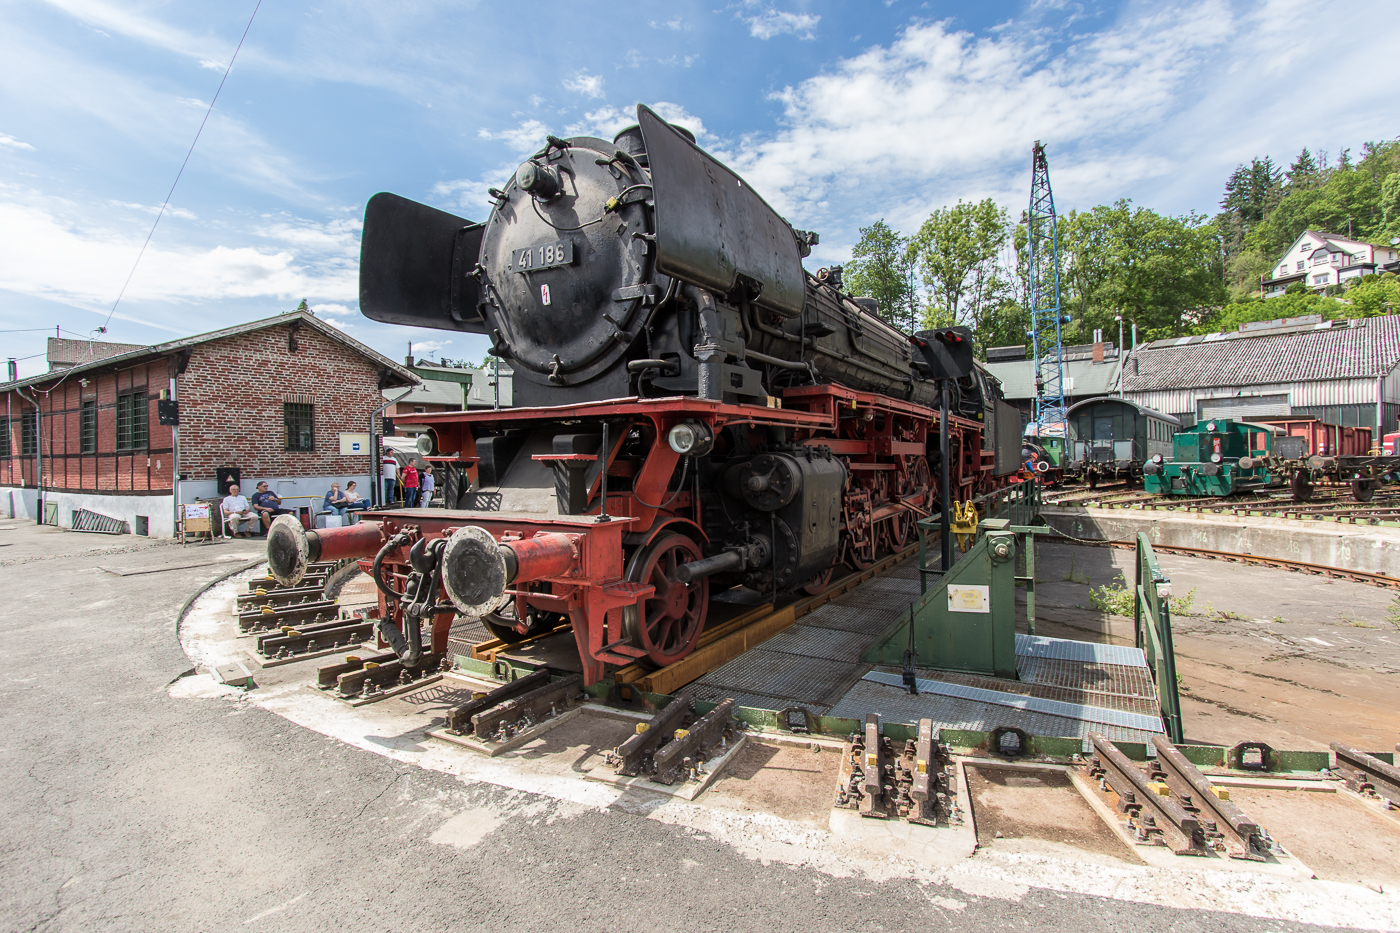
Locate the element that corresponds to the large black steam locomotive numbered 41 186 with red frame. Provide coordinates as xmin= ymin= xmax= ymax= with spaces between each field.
xmin=269 ymin=106 xmax=1021 ymax=682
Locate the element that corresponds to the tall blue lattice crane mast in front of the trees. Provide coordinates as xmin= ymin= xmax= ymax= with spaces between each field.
xmin=1026 ymin=140 xmax=1070 ymax=436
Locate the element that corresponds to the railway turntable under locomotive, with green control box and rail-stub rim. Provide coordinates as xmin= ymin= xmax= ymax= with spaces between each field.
xmin=163 ymin=488 xmax=1400 ymax=925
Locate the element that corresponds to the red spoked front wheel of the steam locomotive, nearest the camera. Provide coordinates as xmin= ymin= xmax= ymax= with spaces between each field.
xmin=623 ymin=534 xmax=710 ymax=667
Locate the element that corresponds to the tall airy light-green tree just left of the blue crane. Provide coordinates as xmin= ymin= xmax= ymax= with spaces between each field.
xmin=911 ymin=198 xmax=1009 ymax=331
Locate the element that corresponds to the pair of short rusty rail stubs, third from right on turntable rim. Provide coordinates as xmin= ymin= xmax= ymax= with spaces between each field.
xmin=836 ymin=713 xmax=963 ymax=827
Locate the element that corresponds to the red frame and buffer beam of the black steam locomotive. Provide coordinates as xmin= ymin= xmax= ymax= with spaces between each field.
xmin=269 ymin=384 xmax=1015 ymax=684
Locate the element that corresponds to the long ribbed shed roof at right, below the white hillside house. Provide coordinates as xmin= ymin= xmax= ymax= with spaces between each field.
xmin=1123 ymin=315 xmax=1400 ymax=392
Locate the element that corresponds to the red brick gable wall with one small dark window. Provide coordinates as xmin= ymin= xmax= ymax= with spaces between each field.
xmin=179 ymin=325 xmax=384 ymax=479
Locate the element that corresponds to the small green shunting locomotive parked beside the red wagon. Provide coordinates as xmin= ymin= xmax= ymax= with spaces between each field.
xmin=1142 ymin=417 xmax=1275 ymax=496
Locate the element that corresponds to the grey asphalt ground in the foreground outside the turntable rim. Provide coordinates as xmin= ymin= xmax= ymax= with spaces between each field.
xmin=0 ymin=520 xmax=1388 ymax=933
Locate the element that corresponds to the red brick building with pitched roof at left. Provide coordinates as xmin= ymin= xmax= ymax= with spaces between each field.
xmin=0 ymin=311 xmax=417 ymax=537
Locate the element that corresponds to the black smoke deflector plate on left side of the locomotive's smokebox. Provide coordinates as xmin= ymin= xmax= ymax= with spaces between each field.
xmin=360 ymin=192 xmax=486 ymax=333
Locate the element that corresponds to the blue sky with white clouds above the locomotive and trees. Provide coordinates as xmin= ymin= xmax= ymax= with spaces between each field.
xmin=0 ymin=0 xmax=1400 ymax=374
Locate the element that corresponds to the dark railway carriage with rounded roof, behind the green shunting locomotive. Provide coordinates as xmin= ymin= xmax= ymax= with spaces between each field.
xmin=1064 ymin=396 xmax=1182 ymax=486
